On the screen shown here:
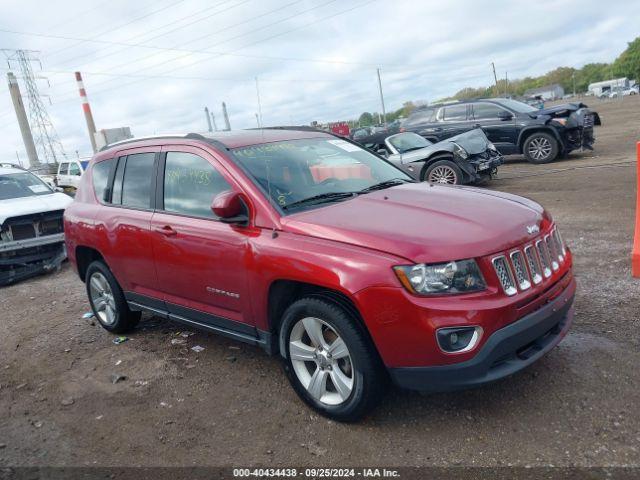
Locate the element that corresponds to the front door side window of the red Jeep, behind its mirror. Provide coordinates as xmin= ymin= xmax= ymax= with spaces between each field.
xmin=164 ymin=152 xmax=231 ymax=218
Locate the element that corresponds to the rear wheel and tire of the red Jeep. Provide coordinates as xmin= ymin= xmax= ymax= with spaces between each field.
xmin=85 ymin=260 xmax=142 ymax=333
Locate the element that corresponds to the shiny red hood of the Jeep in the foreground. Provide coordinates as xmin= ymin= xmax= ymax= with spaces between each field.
xmin=281 ymin=183 xmax=545 ymax=263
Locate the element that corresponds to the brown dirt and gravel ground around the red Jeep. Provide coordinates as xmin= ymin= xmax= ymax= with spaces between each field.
xmin=0 ymin=97 xmax=640 ymax=466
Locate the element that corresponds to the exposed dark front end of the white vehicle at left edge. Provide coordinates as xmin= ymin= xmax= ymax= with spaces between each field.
xmin=0 ymin=210 xmax=67 ymax=286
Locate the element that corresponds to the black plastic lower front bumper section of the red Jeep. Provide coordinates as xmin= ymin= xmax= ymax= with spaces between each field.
xmin=389 ymin=279 xmax=575 ymax=392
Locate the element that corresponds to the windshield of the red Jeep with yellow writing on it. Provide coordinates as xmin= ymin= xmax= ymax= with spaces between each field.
xmin=233 ymin=138 xmax=412 ymax=213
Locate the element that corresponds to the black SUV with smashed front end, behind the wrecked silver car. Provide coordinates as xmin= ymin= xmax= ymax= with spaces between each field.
xmin=401 ymin=98 xmax=600 ymax=163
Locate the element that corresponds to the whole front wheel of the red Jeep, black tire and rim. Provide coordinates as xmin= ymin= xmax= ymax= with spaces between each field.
xmin=280 ymin=297 xmax=386 ymax=422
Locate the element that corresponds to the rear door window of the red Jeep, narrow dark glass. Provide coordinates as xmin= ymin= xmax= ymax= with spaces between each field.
xmin=119 ymin=153 xmax=156 ymax=209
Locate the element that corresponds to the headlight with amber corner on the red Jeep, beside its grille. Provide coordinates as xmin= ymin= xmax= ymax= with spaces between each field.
xmin=393 ymin=260 xmax=487 ymax=295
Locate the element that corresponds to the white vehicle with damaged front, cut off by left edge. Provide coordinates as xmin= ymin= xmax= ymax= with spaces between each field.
xmin=0 ymin=163 xmax=73 ymax=286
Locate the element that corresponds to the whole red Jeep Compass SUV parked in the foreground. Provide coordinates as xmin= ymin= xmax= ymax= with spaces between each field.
xmin=64 ymin=129 xmax=576 ymax=420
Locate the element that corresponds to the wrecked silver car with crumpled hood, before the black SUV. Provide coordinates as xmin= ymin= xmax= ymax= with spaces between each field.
xmin=360 ymin=128 xmax=502 ymax=185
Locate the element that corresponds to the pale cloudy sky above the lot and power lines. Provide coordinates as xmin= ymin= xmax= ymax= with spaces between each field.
xmin=0 ymin=0 xmax=640 ymax=162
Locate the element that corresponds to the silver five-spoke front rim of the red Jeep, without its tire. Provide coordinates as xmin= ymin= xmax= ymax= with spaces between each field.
xmin=289 ymin=317 xmax=355 ymax=405
